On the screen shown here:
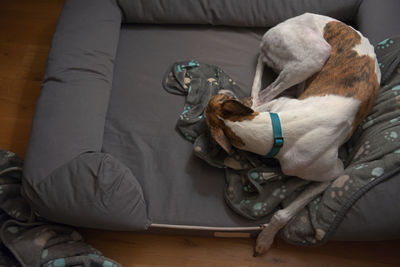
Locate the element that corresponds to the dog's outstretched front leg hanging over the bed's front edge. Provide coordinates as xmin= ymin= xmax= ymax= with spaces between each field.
xmin=254 ymin=182 xmax=330 ymax=256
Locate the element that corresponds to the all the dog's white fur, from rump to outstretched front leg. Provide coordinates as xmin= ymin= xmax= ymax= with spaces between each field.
xmin=225 ymin=13 xmax=381 ymax=255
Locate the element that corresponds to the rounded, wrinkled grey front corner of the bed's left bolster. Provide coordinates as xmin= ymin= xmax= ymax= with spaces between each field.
xmin=22 ymin=152 xmax=150 ymax=231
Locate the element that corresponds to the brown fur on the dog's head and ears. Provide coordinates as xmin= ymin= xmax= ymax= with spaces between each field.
xmin=206 ymin=90 xmax=258 ymax=154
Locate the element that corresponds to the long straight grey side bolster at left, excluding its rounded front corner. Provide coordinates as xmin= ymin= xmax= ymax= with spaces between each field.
xmin=24 ymin=0 xmax=122 ymax=184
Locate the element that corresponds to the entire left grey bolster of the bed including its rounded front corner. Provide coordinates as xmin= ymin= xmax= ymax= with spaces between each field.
xmin=24 ymin=0 xmax=148 ymax=230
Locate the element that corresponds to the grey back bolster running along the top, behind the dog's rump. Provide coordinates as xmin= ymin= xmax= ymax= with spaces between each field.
xmin=117 ymin=0 xmax=360 ymax=27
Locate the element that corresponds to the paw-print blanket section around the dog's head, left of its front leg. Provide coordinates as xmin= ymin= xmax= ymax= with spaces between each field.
xmin=163 ymin=60 xmax=309 ymax=220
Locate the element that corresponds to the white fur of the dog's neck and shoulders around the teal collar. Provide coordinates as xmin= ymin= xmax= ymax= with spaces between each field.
xmin=224 ymin=95 xmax=360 ymax=181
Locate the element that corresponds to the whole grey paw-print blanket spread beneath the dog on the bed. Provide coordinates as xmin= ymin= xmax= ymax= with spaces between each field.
xmin=163 ymin=38 xmax=400 ymax=245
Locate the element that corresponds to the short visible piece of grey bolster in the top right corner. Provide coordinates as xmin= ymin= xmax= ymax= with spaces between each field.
xmin=356 ymin=0 xmax=400 ymax=45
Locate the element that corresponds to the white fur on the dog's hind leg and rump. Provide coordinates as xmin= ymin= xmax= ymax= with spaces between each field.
xmin=251 ymin=13 xmax=381 ymax=107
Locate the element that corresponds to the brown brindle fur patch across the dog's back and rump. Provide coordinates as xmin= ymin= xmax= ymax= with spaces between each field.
xmin=299 ymin=21 xmax=379 ymax=131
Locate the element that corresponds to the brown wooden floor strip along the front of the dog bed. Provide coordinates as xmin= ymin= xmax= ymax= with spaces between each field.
xmin=81 ymin=229 xmax=400 ymax=266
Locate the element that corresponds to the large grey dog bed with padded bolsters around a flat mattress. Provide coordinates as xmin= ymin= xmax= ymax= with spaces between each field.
xmin=22 ymin=0 xmax=400 ymax=243
